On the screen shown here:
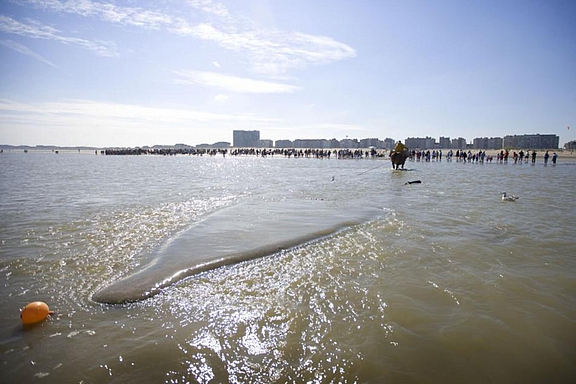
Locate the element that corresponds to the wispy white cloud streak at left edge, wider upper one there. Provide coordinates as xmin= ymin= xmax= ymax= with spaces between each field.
xmin=0 ymin=15 xmax=119 ymax=57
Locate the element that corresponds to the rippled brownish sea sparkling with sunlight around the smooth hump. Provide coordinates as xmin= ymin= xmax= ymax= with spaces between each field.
xmin=0 ymin=151 xmax=576 ymax=383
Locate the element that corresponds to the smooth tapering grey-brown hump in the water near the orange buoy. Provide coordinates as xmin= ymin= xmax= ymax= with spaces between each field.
xmin=92 ymin=199 xmax=382 ymax=304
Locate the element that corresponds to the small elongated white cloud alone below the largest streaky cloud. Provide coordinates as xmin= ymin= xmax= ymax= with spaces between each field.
xmin=176 ymin=71 xmax=301 ymax=93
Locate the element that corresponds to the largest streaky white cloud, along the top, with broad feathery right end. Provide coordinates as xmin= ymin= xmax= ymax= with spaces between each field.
xmin=17 ymin=0 xmax=356 ymax=77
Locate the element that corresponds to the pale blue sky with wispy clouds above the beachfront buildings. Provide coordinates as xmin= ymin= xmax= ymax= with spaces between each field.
xmin=0 ymin=0 xmax=576 ymax=147
